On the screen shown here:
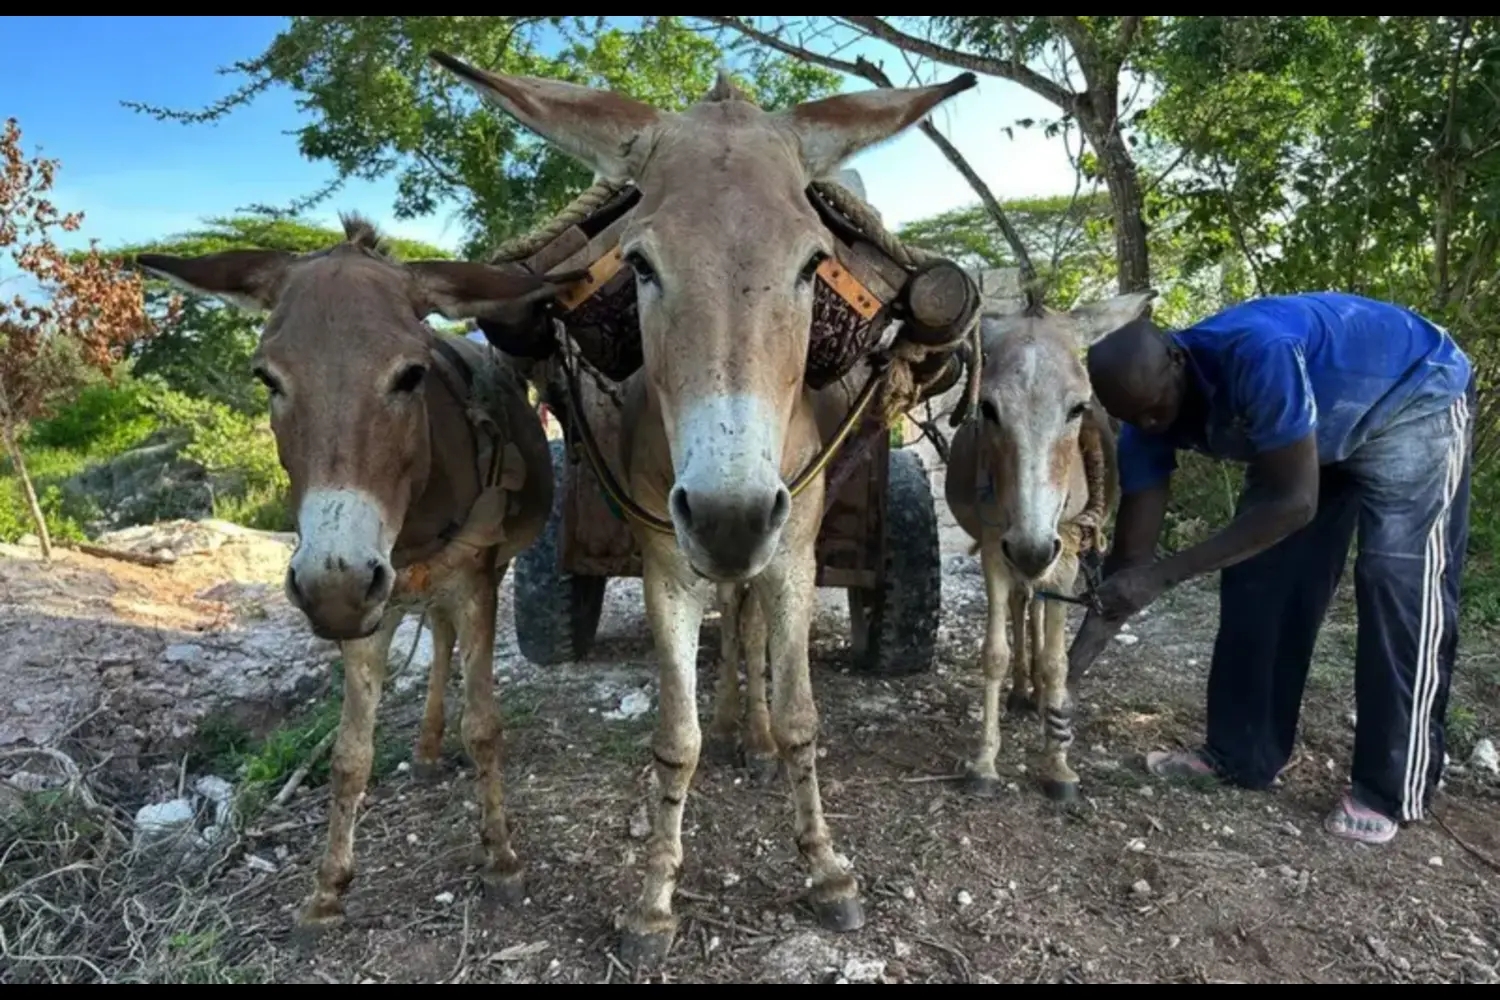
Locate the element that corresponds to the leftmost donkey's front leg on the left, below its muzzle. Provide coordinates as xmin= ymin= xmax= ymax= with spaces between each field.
xmin=297 ymin=610 xmax=405 ymax=943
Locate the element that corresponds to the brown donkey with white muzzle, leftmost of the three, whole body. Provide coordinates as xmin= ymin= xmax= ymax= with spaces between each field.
xmin=137 ymin=216 xmax=576 ymax=933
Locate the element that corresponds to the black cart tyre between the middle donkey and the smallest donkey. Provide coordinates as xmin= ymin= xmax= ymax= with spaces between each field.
xmin=848 ymin=448 xmax=942 ymax=676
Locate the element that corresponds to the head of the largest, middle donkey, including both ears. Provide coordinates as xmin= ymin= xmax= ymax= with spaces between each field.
xmin=432 ymin=52 xmax=974 ymax=582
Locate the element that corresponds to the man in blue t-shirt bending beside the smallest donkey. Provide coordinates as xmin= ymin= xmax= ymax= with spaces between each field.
xmin=1074 ymin=292 xmax=1475 ymax=844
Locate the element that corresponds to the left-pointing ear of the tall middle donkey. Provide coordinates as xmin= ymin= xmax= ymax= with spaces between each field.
xmin=428 ymin=49 xmax=672 ymax=183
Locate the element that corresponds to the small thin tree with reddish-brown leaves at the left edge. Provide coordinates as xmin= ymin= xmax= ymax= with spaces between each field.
xmin=0 ymin=118 xmax=150 ymax=559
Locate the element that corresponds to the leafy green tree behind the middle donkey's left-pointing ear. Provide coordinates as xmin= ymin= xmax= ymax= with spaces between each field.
xmin=126 ymin=15 xmax=839 ymax=258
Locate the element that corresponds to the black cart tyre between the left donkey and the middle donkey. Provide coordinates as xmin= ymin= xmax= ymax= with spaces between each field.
xmin=512 ymin=441 xmax=609 ymax=667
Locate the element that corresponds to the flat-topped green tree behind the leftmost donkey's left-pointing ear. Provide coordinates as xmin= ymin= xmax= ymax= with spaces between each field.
xmin=114 ymin=214 xmax=452 ymax=415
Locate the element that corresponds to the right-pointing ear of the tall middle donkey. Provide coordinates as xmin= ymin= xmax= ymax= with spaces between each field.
xmin=777 ymin=73 xmax=978 ymax=177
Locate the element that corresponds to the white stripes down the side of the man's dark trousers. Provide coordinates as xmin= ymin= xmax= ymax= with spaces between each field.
xmin=1401 ymin=396 xmax=1469 ymax=822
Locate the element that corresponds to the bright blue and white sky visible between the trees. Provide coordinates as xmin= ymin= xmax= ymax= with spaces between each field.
xmin=0 ymin=16 xmax=1073 ymax=257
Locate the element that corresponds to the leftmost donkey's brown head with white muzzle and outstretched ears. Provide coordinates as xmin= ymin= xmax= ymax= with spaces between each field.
xmin=135 ymin=216 xmax=579 ymax=640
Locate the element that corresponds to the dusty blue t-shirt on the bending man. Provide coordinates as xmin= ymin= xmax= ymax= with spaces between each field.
xmin=1119 ymin=292 xmax=1470 ymax=493
